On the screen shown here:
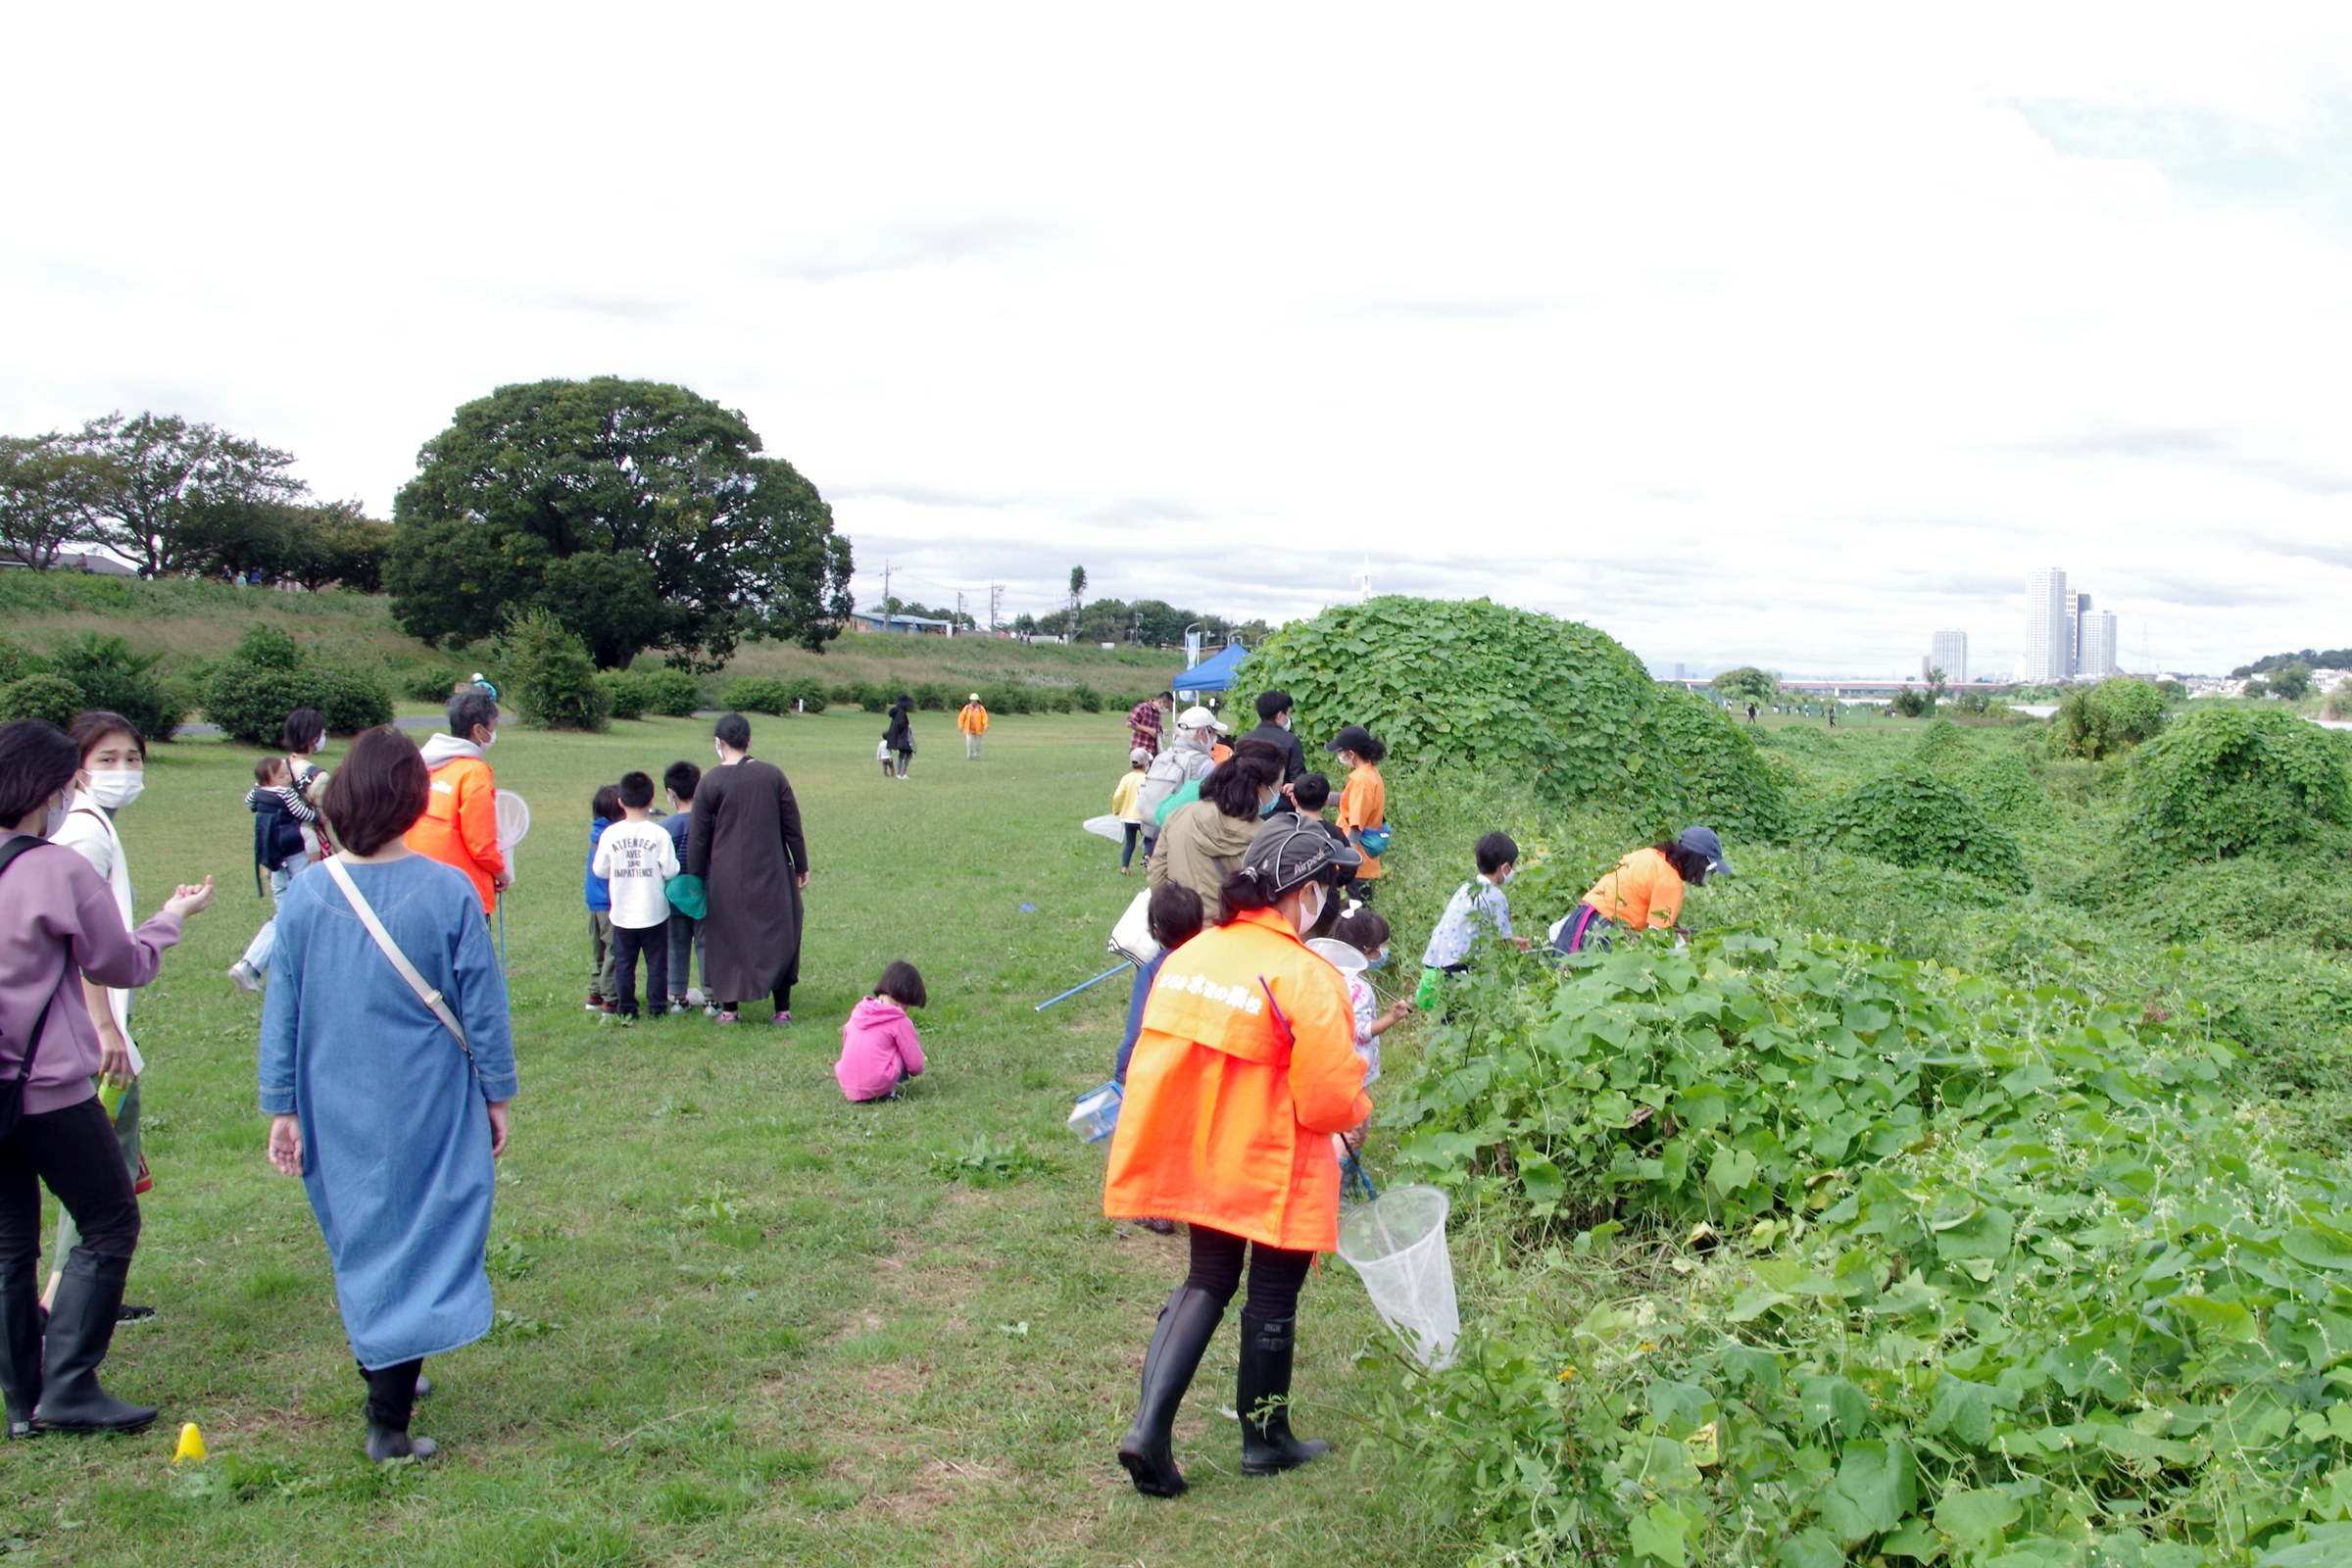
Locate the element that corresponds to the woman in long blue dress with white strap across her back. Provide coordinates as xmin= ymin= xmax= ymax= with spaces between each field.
xmin=261 ymin=726 xmax=515 ymax=1460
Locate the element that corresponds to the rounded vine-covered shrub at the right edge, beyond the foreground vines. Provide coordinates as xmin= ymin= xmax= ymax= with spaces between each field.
xmin=2127 ymin=706 xmax=2352 ymax=860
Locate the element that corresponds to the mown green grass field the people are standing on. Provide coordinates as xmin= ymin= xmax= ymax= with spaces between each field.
xmin=0 ymin=712 xmax=1460 ymax=1568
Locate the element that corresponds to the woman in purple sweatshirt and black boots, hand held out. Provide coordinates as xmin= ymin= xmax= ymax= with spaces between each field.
xmin=0 ymin=719 xmax=212 ymax=1439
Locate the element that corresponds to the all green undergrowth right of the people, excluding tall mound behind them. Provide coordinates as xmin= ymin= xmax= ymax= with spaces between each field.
xmin=1354 ymin=706 xmax=2352 ymax=1568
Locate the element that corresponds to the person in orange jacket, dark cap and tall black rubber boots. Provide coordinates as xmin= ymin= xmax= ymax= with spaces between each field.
xmin=1103 ymin=815 xmax=1371 ymax=1497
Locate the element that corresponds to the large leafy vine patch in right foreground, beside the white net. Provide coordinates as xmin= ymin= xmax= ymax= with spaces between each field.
xmin=1383 ymin=936 xmax=2352 ymax=1568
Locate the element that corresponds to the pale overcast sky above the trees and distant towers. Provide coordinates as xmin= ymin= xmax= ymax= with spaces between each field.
xmin=0 ymin=0 xmax=2352 ymax=674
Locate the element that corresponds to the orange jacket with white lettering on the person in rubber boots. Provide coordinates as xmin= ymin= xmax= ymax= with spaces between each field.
xmin=1103 ymin=909 xmax=1371 ymax=1253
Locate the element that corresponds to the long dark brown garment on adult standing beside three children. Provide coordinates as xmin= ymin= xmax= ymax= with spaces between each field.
xmin=687 ymin=757 xmax=809 ymax=1002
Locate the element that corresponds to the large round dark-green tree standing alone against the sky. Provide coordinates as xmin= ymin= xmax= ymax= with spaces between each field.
xmin=383 ymin=376 xmax=852 ymax=670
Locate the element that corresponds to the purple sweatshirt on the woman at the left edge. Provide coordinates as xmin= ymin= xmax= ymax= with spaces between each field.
xmin=0 ymin=835 xmax=178 ymax=1116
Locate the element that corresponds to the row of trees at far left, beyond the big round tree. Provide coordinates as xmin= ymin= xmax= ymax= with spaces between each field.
xmin=0 ymin=412 xmax=393 ymax=592
